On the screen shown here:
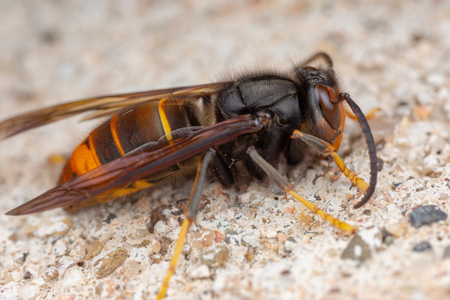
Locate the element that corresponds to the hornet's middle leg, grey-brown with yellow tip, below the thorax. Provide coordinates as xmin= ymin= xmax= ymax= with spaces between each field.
xmin=247 ymin=147 xmax=356 ymax=234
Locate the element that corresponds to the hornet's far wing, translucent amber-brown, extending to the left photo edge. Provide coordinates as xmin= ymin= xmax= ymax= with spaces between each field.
xmin=0 ymin=82 xmax=228 ymax=140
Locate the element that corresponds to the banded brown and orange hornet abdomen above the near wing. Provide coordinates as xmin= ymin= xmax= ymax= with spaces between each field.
xmin=59 ymin=99 xmax=192 ymax=186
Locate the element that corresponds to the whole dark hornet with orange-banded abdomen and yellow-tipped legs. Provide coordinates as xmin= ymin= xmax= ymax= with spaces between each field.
xmin=0 ymin=53 xmax=377 ymax=299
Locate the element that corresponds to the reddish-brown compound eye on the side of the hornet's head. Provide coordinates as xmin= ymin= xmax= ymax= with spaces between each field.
xmin=314 ymin=84 xmax=342 ymax=130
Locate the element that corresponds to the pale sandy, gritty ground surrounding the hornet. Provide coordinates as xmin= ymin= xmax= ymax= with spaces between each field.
xmin=0 ymin=0 xmax=450 ymax=299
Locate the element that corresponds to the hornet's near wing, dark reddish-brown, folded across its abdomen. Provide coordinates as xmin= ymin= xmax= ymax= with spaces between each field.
xmin=7 ymin=115 xmax=266 ymax=215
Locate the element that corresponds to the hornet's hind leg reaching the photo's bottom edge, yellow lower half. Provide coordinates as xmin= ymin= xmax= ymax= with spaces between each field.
xmin=157 ymin=149 xmax=216 ymax=300
